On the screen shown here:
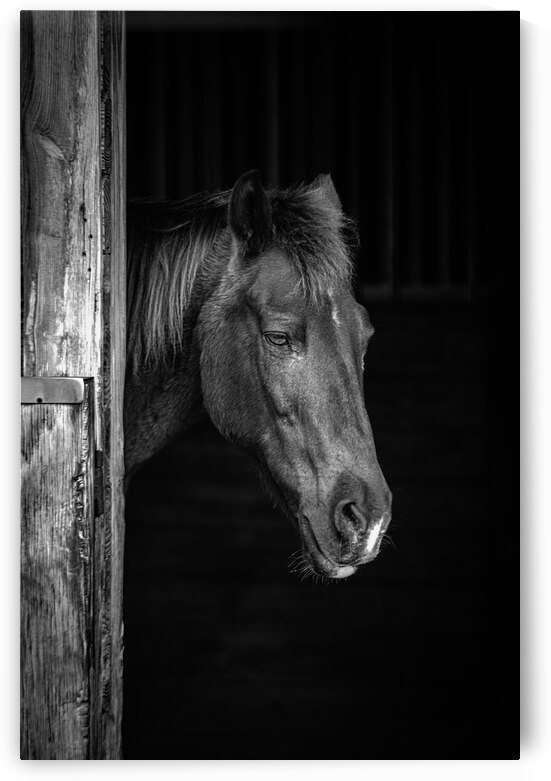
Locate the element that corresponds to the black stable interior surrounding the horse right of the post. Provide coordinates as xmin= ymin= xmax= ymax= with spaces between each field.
xmin=123 ymin=12 xmax=519 ymax=759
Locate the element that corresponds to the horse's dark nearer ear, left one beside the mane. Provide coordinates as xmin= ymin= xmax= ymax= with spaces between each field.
xmin=229 ymin=171 xmax=272 ymax=257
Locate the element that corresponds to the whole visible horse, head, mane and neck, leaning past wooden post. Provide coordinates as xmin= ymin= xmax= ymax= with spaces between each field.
xmin=124 ymin=170 xmax=392 ymax=580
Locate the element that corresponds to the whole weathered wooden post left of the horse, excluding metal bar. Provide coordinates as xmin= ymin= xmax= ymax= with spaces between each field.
xmin=21 ymin=11 xmax=126 ymax=759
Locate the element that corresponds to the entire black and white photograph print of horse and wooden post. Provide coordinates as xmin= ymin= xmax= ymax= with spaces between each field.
xmin=16 ymin=1 xmax=532 ymax=761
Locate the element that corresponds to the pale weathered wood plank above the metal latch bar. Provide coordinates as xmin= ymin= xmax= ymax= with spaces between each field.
xmin=21 ymin=12 xmax=102 ymax=377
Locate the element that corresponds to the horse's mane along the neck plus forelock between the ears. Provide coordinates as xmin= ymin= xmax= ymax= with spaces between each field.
xmin=127 ymin=183 xmax=357 ymax=370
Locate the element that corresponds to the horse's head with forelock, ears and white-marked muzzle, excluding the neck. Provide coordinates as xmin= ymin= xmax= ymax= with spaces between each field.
xmin=197 ymin=171 xmax=391 ymax=578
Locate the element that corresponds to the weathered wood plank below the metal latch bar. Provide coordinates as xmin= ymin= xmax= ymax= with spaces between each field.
xmin=21 ymin=382 xmax=94 ymax=759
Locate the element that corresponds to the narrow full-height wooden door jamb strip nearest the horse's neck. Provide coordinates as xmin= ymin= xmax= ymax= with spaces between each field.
xmin=91 ymin=12 xmax=126 ymax=759
